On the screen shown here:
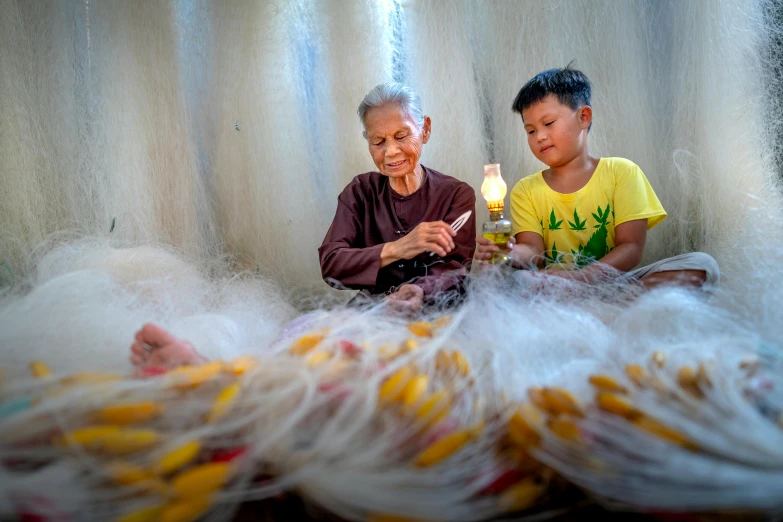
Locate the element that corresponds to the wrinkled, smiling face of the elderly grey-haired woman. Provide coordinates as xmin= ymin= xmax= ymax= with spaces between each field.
xmin=364 ymin=103 xmax=431 ymax=178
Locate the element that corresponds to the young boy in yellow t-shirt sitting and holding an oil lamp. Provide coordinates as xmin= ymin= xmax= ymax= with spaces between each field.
xmin=475 ymin=67 xmax=720 ymax=288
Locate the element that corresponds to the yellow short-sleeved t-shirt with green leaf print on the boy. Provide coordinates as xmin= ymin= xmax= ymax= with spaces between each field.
xmin=510 ymin=158 xmax=666 ymax=268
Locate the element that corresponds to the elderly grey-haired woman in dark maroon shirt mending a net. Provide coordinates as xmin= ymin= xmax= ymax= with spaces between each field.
xmin=318 ymin=83 xmax=476 ymax=310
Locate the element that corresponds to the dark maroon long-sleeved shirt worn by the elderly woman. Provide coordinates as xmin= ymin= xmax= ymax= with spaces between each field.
xmin=318 ymin=165 xmax=476 ymax=295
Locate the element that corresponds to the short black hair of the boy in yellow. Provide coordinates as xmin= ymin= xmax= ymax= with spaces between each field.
xmin=511 ymin=64 xmax=592 ymax=130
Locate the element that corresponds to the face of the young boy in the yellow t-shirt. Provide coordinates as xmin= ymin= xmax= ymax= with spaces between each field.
xmin=522 ymin=94 xmax=593 ymax=167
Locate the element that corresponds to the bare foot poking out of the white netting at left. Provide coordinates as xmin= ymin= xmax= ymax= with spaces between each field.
xmin=130 ymin=323 xmax=206 ymax=371
